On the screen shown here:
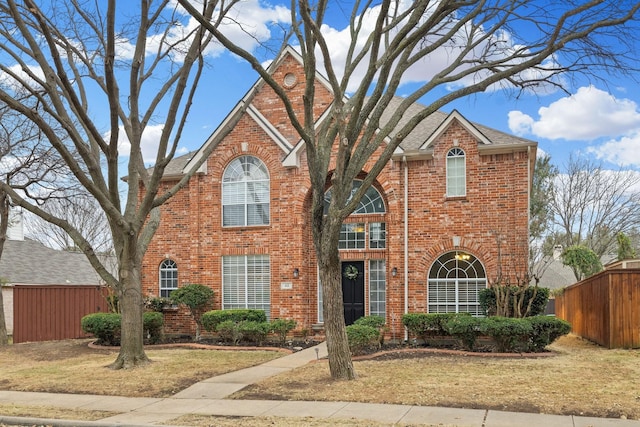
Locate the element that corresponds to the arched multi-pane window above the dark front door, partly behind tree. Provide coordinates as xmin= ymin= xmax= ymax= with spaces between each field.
xmin=324 ymin=180 xmax=387 ymax=250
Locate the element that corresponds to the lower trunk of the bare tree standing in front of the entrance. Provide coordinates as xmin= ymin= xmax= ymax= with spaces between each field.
xmin=318 ymin=245 xmax=356 ymax=380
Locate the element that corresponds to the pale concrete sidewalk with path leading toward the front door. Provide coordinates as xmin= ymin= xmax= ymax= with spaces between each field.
xmin=0 ymin=343 xmax=640 ymax=427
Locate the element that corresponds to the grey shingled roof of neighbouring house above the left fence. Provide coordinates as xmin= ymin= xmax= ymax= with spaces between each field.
xmin=0 ymin=239 xmax=103 ymax=285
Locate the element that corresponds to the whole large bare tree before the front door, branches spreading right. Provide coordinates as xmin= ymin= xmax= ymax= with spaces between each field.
xmin=179 ymin=0 xmax=640 ymax=379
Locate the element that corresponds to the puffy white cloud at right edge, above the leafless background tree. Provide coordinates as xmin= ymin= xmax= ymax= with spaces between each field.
xmin=509 ymin=86 xmax=640 ymax=141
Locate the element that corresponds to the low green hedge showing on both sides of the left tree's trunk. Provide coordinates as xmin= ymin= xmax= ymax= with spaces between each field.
xmin=80 ymin=312 xmax=164 ymax=346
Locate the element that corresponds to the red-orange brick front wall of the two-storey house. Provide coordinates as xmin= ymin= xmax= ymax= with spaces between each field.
xmin=143 ymin=47 xmax=535 ymax=337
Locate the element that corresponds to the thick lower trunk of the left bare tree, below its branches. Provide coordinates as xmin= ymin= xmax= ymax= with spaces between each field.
xmin=109 ymin=238 xmax=149 ymax=369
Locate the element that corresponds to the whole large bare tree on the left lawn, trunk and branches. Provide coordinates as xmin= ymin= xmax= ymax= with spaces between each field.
xmin=0 ymin=0 xmax=242 ymax=368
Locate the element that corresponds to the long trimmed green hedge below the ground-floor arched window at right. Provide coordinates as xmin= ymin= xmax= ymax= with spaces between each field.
xmin=402 ymin=313 xmax=571 ymax=352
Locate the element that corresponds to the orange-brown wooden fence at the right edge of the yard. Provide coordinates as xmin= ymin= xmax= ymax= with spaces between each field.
xmin=556 ymin=268 xmax=640 ymax=348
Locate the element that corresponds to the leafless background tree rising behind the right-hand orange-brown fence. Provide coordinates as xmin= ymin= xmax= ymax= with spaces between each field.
xmin=551 ymin=156 xmax=640 ymax=280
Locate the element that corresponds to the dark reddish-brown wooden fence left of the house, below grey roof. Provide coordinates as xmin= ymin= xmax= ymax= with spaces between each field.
xmin=13 ymin=285 xmax=108 ymax=343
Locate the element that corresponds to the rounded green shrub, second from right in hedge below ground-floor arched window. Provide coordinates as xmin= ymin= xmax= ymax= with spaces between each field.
xmin=481 ymin=316 xmax=533 ymax=353
